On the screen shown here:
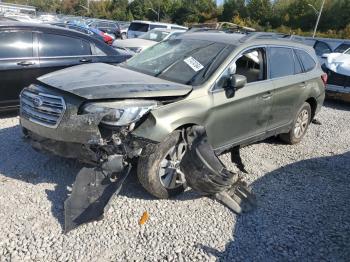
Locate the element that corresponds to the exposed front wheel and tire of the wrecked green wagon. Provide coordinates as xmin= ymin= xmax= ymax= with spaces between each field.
xmin=137 ymin=131 xmax=186 ymax=199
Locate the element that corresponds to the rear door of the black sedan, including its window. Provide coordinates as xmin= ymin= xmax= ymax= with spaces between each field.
xmin=38 ymin=33 xmax=93 ymax=75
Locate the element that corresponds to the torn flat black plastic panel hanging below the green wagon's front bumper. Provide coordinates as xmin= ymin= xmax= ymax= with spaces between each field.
xmin=64 ymin=165 xmax=131 ymax=233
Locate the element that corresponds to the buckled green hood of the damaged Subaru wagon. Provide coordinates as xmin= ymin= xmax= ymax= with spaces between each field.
xmin=38 ymin=63 xmax=192 ymax=99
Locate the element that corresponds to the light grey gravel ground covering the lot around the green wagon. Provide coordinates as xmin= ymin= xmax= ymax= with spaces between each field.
xmin=0 ymin=102 xmax=350 ymax=261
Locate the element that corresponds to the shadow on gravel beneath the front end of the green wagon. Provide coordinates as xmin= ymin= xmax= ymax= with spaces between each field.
xmin=0 ymin=125 xmax=200 ymax=229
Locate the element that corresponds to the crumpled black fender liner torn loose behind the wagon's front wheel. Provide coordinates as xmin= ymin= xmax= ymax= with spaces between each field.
xmin=181 ymin=127 xmax=255 ymax=214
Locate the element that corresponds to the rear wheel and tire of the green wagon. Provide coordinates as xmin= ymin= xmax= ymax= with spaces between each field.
xmin=280 ymin=102 xmax=311 ymax=145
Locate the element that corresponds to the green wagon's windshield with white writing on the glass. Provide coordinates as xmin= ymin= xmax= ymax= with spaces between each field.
xmin=123 ymin=39 xmax=234 ymax=85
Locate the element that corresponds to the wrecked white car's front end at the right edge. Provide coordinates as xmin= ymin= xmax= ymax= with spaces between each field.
xmin=323 ymin=50 xmax=350 ymax=102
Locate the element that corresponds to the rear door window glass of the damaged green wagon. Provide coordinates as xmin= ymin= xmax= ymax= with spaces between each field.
xmin=269 ymin=47 xmax=295 ymax=78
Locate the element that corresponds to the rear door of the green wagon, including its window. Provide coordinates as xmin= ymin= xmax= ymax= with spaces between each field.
xmin=268 ymin=47 xmax=307 ymax=130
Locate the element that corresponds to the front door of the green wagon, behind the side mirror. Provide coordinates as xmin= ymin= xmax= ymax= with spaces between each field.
xmin=206 ymin=48 xmax=273 ymax=150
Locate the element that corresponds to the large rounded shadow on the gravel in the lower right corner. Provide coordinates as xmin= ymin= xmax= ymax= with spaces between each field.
xmin=199 ymin=152 xmax=350 ymax=261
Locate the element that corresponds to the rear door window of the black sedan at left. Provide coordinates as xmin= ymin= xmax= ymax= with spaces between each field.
xmin=39 ymin=34 xmax=91 ymax=57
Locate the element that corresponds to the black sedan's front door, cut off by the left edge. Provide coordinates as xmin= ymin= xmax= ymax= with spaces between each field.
xmin=0 ymin=30 xmax=39 ymax=110
